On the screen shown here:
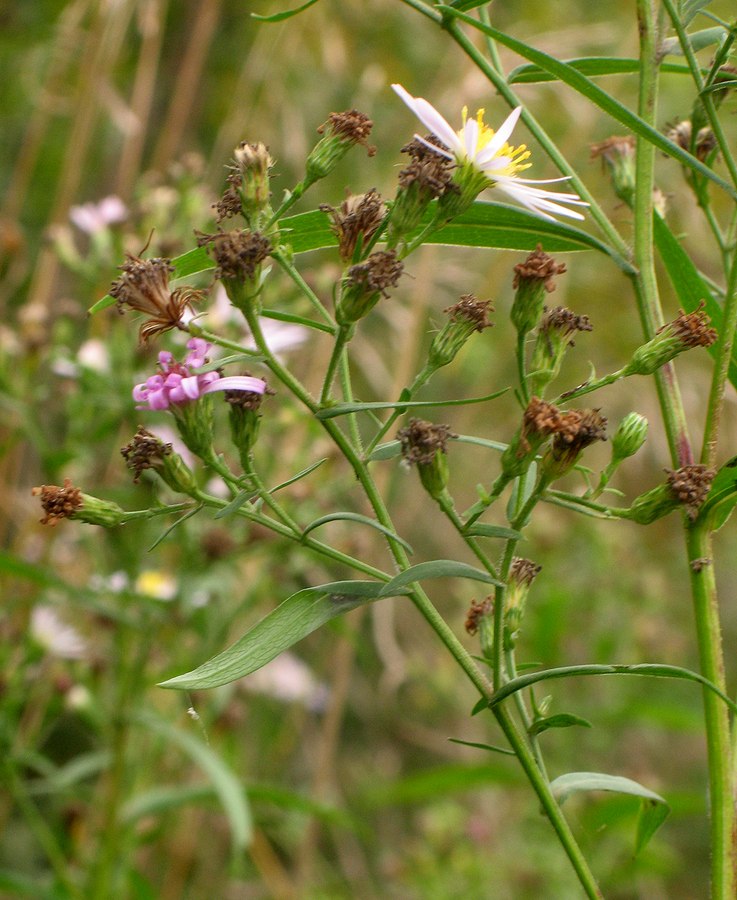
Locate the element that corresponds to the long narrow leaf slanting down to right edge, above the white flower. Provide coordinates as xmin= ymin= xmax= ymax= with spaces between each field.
xmin=436 ymin=5 xmax=737 ymax=200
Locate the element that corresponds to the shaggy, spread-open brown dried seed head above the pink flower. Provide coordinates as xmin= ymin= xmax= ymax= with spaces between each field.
xmin=110 ymin=255 xmax=204 ymax=343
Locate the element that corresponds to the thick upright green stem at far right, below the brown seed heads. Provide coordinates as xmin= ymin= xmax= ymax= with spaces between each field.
xmin=686 ymin=520 xmax=737 ymax=900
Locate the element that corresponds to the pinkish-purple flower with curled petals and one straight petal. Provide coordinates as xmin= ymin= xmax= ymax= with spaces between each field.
xmin=133 ymin=338 xmax=266 ymax=410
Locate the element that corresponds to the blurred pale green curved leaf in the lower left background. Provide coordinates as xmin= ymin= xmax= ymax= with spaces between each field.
xmin=135 ymin=713 xmax=252 ymax=850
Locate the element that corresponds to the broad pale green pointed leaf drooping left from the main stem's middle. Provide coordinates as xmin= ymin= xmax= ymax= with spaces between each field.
xmin=159 ymin=581 xmax=397 ymax=690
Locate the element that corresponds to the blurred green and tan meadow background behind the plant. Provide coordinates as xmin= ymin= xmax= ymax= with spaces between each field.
xmin=0 ymin=0 xmax=737 ymax=900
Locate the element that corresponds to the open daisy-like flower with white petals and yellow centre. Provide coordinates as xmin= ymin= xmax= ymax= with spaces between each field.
xmin=392 ymin=84 xmax=589 ymax=221
